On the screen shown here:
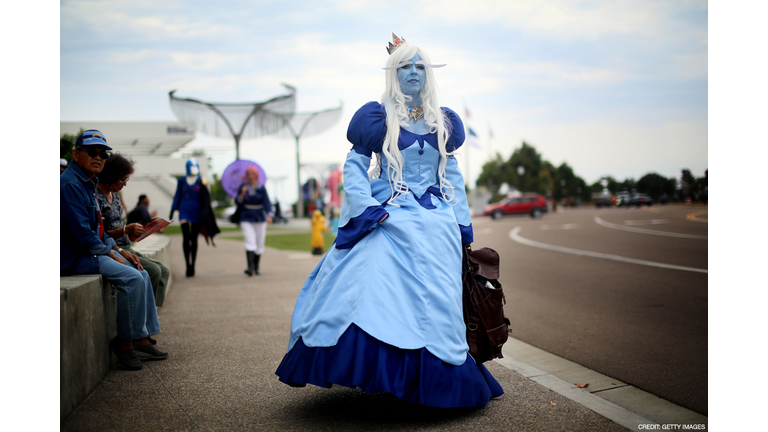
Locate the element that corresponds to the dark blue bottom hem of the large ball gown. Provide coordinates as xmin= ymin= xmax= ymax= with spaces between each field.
xmin=275 ymin=324 xmax=504 ymax=408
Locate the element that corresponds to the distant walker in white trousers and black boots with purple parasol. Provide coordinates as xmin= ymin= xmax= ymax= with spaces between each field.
xmin=236 ymin=165 xmax=274 ymax=276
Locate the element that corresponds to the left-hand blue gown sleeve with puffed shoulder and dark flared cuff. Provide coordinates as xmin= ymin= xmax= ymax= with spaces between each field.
xmin=336 ymin=102 xmax=388 ymax=249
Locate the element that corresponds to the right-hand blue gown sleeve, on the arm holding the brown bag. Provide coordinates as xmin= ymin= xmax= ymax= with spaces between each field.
xmin=443 ymin=107 xmax=474 ymax=243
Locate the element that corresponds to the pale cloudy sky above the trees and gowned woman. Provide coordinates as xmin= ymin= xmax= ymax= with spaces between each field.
xmin=60 ymin=0 xmax=708 ymax=198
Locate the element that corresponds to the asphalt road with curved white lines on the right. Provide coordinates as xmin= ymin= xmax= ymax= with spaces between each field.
xmin=473 ymin=205 xmax=708 ymax=415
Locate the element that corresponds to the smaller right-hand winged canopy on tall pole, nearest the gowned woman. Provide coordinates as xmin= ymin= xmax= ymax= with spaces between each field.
xmin=268 ymin=101 xmax=344 ymax=217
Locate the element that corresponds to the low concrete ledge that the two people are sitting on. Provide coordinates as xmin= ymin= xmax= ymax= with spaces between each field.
xmin=59 ymin=234 xmax=172 ymax=419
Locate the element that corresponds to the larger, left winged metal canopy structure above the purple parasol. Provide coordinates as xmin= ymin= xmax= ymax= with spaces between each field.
xmin=168 ymin=84 xmax=296 ymax=160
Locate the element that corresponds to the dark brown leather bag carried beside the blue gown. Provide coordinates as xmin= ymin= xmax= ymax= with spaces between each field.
xmin=462 ymin=245 xmax=512 ymax=364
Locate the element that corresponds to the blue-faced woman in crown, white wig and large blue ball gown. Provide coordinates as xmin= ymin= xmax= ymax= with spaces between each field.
xmin=276 ymin=35 xmax=503 ymax=407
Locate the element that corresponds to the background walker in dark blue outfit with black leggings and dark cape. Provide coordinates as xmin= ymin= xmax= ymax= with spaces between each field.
xmin=169 ymin=158 xmax=219 ymax=277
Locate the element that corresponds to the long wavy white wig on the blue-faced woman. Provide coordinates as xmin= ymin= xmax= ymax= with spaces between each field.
xmin=369 ymin=43 xmax=454 ymax=206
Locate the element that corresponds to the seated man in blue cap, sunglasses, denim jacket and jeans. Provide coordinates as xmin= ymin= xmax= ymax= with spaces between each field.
xmin=59 ymin=129 xmax=168 ymax=370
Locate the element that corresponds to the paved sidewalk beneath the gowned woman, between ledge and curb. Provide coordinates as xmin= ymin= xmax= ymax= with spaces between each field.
xmin=61 ymin=225 xmax=626 ymax=431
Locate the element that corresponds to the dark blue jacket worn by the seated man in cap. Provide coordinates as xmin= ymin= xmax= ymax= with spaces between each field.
xmin=59 ymin=163 xmax=117 ymax=276
